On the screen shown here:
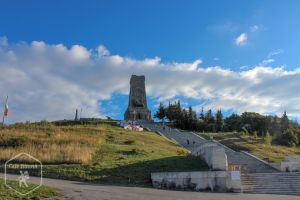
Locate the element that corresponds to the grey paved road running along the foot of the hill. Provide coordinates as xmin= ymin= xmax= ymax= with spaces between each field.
xmin=0 ymin=173 xmax=299 ymax=200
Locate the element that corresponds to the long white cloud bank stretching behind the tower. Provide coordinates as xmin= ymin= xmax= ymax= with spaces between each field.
xmin=0 ymin=37 xmax=300 ymax=122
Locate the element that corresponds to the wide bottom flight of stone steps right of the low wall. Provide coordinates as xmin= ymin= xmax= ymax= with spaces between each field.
xmin=241 ymin=172 xmax=300 ymax=195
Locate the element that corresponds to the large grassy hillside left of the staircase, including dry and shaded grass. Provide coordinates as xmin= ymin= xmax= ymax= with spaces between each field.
xmin=0 ymin=121 xmax=207 ymax=186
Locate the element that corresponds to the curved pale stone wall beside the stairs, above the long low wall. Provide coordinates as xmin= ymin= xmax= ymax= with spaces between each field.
xmin=192 ymin=142 xmax=228 ymax=171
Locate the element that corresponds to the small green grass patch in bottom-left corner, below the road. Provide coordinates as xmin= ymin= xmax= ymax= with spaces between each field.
xmin=0 ymin=179 xmax=57 ymax=200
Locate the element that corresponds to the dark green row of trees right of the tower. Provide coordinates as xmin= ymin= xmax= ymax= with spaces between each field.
xmin=154 ymin=100 xmax=300 ymax=146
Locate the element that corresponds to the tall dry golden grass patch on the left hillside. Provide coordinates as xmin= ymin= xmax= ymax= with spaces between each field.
xmin=0 ymin=123 xmax=105 ymax=164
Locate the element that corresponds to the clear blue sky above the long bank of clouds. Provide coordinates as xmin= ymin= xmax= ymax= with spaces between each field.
xmin=0 ymin=0 xmax=300 ymax=69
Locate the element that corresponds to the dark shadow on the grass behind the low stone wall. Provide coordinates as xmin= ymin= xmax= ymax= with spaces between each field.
xmin=82 ymin=156 xmax=208 ymax=186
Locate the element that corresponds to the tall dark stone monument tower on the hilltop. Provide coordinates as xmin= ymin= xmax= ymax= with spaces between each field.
xmin=124 ymin=75 xmax=151 ymax=121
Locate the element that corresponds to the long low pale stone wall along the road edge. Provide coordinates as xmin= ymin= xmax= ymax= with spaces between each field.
xmin=151 ymin=171 xmax=241 ymax=192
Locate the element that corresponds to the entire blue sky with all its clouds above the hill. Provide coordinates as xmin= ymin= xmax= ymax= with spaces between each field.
xmin=0 ymin=0 xmax=300 ymax=123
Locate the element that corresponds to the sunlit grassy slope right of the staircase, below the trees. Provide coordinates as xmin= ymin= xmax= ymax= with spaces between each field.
xmin=199 ymin=133 xmax=300 ymax=162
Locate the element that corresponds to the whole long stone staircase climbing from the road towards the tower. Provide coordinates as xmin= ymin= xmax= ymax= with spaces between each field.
xmin=142 ymin=123 xmax=300 ymax=195
